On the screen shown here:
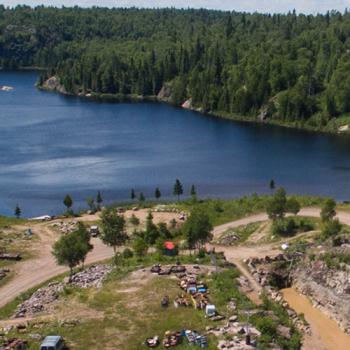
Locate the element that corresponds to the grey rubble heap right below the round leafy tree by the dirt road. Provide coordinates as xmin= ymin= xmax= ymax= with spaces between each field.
xmin=69 ymin=265 xmax=113 ymax=288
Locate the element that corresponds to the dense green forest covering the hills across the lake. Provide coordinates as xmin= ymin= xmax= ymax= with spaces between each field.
xmin=0 ymin=6 xmax=350 ymax=128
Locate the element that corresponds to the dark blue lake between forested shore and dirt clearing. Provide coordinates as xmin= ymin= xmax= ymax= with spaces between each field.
xmin=0 ymin=71 xmax=350 ymax=217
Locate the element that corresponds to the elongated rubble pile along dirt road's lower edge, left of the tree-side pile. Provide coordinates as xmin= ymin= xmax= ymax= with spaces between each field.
xmin=15 ymin=282 xmax=64 ymax=318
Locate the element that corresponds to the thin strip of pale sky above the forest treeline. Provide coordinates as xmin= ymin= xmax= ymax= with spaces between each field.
xmin=0 ymin=0 xmax=350 ymax=13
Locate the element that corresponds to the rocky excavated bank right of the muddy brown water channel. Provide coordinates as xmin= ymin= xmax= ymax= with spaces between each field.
xmin=293 ymin=261 xmax=350 ymax=334
